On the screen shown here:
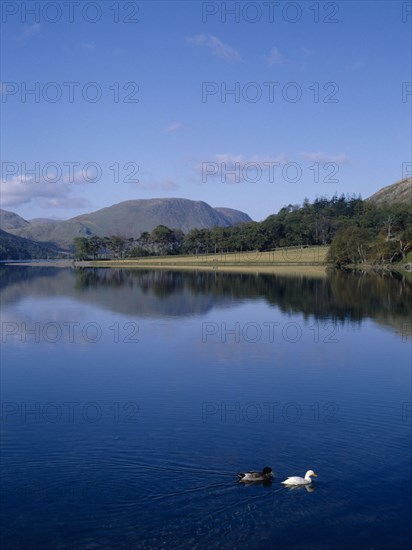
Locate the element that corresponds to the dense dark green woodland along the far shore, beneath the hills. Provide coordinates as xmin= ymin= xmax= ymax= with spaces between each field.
xmin=75 ymin=195 xmax=412 ymax=265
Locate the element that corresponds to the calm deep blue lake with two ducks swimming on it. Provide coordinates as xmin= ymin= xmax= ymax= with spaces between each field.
xmin=0 ymin=266 xmax=412 ymax=550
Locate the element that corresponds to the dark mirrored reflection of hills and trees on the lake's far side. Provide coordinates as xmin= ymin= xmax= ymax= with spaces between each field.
xmin=0 ymin=266 xmax=412 ymax=333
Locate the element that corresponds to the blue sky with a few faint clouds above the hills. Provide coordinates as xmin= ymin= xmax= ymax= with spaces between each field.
xmin=1 ymin=0 xmax=412 ymax=220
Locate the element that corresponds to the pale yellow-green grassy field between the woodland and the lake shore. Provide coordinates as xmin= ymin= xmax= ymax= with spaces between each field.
xmin=85 ymin=246 xmax=328 ymax=276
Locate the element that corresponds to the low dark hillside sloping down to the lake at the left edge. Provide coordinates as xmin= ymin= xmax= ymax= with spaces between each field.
xmin=0 ymin=229 xmax=60 ymax=260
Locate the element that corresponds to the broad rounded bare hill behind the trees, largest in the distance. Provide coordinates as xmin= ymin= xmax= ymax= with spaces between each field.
xmin=6 ymin=199 xmax=252 ymax=248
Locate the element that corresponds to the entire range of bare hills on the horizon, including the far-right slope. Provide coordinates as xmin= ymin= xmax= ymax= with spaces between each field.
xmin=0 ymin=178 xmax=412 ymax=259
